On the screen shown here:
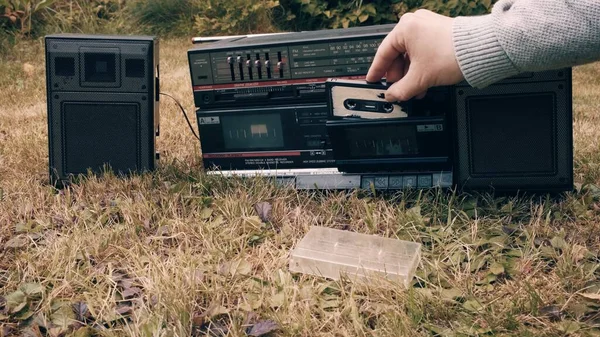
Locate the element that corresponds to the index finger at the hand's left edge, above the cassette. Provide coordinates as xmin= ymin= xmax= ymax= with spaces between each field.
xmin=366 ymin=25 xmax=406 ymax=82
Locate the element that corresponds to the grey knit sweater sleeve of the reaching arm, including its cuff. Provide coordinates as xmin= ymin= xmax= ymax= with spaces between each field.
xmin=453 ymin=0 xmax=600 ymax=88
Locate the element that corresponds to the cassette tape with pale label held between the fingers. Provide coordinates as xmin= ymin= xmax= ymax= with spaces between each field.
xmin=326 ymin=78 xmax=412 ymax=119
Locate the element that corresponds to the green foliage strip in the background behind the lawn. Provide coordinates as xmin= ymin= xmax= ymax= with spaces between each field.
xmin=0 ymin=0 xmax=495 ymax=50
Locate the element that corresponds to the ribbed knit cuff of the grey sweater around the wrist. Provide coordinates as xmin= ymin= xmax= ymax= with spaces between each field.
xmin=452 ymin=15 xmax=519 ymax=88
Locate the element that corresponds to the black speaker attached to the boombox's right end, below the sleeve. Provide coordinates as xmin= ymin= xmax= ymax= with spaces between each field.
xmin=455 ymin=69 xmax=573 ymax=191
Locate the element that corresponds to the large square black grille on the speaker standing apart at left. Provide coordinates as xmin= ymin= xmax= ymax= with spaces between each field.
xmin=62 ymin=102 xmax=141 ymax=174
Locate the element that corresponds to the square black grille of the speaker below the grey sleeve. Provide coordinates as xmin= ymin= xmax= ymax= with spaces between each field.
xmin=467 ymin=93 xmax=556 ymax=176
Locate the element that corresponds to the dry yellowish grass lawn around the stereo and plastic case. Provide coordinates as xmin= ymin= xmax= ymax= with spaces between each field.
xmin=0 ymin=40 xmax=600 ymax=336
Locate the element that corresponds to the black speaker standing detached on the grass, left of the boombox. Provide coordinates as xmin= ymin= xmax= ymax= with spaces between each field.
xmin=45 ymin=34 xmax=160 ymax=183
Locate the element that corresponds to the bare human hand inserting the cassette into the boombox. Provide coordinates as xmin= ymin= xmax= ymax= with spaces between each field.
xmin=366 ymin=9 xmax=464 ymax=101
